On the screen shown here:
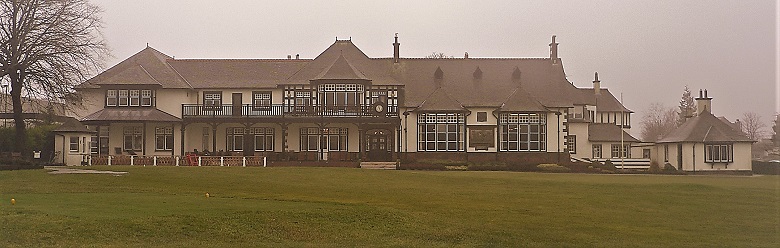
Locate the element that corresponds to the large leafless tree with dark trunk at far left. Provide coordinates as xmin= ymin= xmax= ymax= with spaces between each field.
xmin=0 ymin=0 xmax=108 ymax=152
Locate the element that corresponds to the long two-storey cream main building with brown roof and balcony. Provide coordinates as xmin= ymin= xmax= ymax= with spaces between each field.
xmin=59 ymin=36 xmax=652 ymax=167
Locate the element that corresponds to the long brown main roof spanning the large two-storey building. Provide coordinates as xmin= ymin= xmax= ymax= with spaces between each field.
xmin=79 ymin=40 xmax=630 ymax=111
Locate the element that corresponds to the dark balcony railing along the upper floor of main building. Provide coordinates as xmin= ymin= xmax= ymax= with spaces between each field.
xmin=181 ymin=104 xmax=398 ymax=118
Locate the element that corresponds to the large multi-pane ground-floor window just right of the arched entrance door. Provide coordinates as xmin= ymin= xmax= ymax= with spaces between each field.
xmin=417 ymin=113 xmax=464 ymax=151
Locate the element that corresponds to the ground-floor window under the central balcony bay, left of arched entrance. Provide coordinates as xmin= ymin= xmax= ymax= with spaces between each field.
xmin=301 ymin=127 xmax=349 ymax=151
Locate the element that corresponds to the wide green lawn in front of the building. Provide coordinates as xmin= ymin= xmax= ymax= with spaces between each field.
xmin=0 ymin=166 xmax=780 ymax=247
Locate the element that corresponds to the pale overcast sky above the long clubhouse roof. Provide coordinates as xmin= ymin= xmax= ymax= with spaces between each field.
xmin=94 ymin=0 xmax=780 ymax=136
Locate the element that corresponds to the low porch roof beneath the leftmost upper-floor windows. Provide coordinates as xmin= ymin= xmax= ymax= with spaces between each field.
xmin=81 ymin=108 xmax=181 ymax=123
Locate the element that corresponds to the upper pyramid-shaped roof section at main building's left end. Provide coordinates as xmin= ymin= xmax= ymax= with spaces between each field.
xmin=76 ymin=47 xmax=190 ymax=89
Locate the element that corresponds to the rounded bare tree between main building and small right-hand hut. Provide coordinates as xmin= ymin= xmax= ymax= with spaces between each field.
xmin=641 ymin=103 xmax=677 ymax=142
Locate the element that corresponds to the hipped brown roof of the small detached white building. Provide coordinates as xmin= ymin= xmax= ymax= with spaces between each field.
xmin=658 ymin=111 xmax=753 ymax=143
